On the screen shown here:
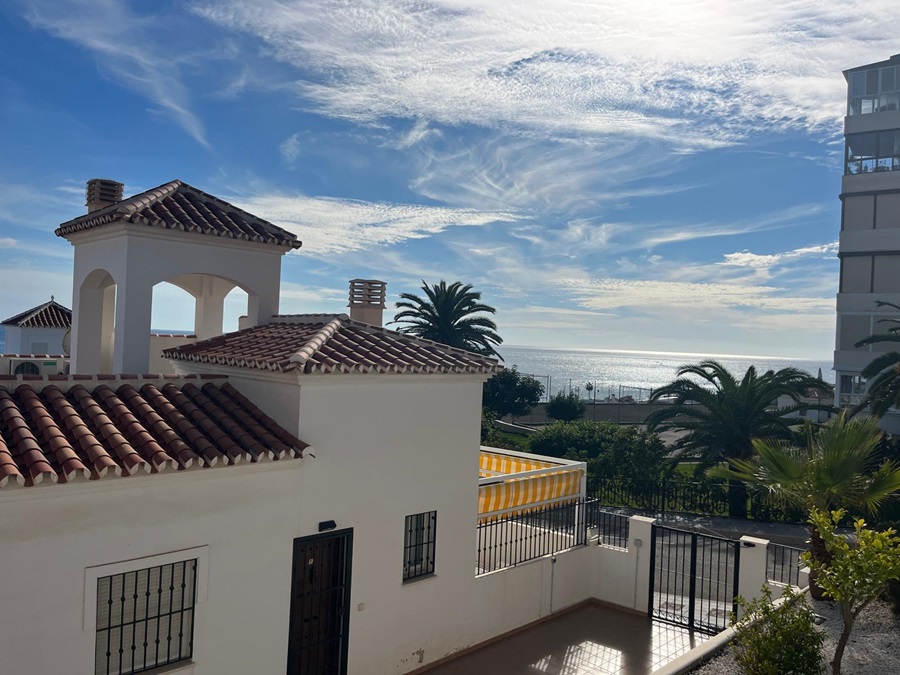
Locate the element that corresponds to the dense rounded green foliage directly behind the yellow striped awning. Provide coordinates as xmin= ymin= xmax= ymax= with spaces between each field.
xmin=529 ymin=420 xmax=667 ymax=491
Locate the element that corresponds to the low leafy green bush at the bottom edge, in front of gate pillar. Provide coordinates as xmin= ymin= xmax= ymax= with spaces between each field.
xmin=731 ymin=584 xmax=825 ymax=675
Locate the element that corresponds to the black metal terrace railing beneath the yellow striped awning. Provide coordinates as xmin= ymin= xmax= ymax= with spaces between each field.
xmin=476 ymin=500 xmax=594 ymax=574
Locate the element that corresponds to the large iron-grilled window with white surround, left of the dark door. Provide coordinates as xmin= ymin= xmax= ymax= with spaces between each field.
xmin=94 ymin=558 xmax=197 ymax=675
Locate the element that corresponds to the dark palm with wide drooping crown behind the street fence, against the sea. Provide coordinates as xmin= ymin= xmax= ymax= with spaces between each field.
xmin=646 ymin=359 xmax=833 ymax=517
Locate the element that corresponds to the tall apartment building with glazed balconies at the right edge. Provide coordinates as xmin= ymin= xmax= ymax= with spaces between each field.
xmin=834 ymin=54 xmax=900 ymax=431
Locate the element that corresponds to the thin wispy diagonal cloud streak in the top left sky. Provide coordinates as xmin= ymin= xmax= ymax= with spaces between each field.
xmin=22 ymin=0 xmax=208 ymax=146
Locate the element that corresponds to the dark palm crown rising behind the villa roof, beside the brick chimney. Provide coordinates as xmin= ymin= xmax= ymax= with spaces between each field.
xmin=391 ymin=279 xmax=503 ymax=358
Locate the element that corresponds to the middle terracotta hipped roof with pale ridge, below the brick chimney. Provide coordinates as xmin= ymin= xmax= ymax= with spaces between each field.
xmin=163 ymin=314 xmax=500 ymax=374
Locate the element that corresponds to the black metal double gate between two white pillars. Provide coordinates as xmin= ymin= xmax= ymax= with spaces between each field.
xmin=649 ymin=525 xmax=741 ymax=633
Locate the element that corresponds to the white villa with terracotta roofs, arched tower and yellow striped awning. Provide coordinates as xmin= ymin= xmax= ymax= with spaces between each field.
xmin=0 ymin=180 xmax=796 ymax=675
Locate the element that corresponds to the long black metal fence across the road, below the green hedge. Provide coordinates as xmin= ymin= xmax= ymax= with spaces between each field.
xmin=591 ymin=478 xmax=805 ymax=523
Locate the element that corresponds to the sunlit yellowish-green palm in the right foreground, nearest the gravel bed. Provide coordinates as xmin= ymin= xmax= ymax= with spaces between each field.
xmin=710 ymin=413 xmax=900 ymax=600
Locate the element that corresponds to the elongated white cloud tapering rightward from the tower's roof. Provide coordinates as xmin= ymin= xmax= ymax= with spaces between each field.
xmin=231 ymin=193 xmax=523 ymax=255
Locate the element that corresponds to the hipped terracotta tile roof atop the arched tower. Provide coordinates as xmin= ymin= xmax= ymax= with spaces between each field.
xmin=56 ymin=180 xmax=301 ymax=248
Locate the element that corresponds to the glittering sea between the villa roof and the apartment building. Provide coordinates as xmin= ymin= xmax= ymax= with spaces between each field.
xmin=498 ymin=345 xmax=834 ymax=400
